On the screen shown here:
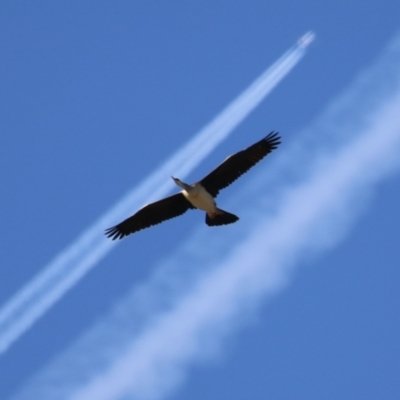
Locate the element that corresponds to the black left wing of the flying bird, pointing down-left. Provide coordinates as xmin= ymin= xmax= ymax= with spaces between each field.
xmin=105 ymin=193 xmax=194 ymax=240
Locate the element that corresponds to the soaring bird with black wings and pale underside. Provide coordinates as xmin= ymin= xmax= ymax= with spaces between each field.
xmin=105 ymin=131 xmax=281 ymax=240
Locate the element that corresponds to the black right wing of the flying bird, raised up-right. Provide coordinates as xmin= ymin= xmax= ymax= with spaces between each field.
xmin=200 ymin=132 xmax=281 ymax=197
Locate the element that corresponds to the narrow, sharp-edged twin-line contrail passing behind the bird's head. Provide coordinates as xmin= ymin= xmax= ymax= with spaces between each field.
xmin=0 ymin=36 xmax=308 ymax=353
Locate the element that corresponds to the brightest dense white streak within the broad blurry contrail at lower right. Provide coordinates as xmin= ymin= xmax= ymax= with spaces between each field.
xmin=68 ymin=64 xmax=400 ymax=400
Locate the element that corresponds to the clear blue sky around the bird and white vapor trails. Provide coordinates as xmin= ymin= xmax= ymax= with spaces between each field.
xmin=0 ymin=1 xmax=400 ymax=399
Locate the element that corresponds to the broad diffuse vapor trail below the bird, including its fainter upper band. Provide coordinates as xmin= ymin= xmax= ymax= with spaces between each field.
xmin=10 ymin=33 xmax=400 ymax=400
